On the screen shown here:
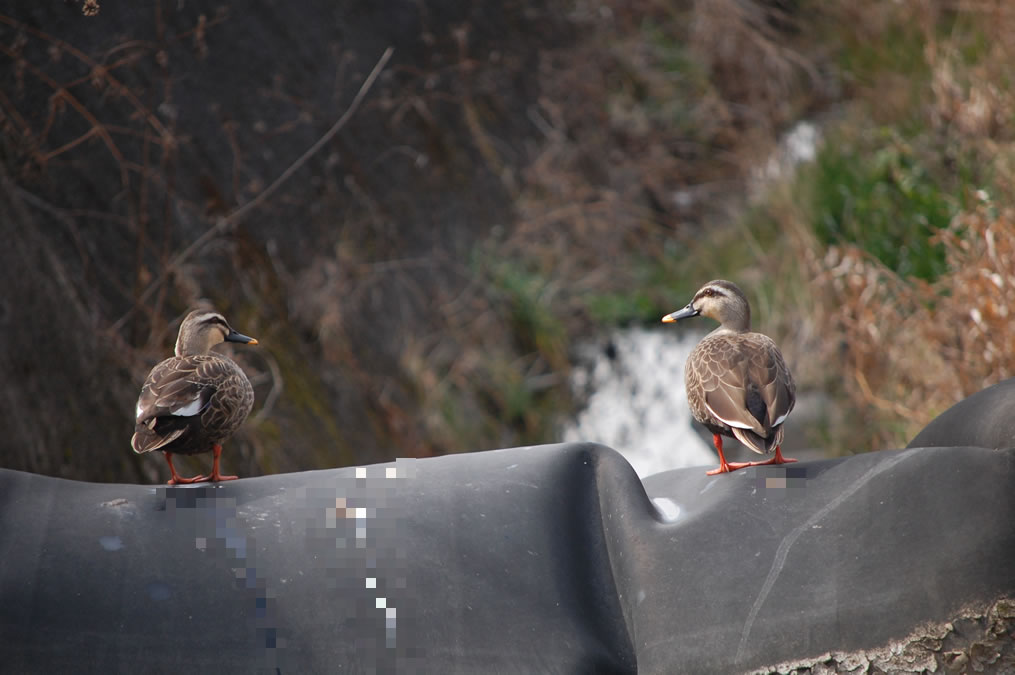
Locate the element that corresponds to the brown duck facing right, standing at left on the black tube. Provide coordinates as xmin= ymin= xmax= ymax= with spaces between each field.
xmin=131 ymin=310 xmax=258 ymax=485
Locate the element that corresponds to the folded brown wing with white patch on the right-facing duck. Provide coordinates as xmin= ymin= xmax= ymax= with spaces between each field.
xmin=131 ymin=355 xmax=218 ymax=453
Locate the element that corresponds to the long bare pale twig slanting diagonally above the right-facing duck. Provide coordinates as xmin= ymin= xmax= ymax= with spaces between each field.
xmin=110 ymin=47 xmax=395 ymax=333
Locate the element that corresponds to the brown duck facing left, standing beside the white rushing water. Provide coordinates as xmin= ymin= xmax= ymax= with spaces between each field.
xmin=663 ymin=279 xmax=797 ymax=476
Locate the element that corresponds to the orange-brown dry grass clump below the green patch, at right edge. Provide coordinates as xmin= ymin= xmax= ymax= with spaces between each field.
xmin=817 ymin=200 xmax=1015 ymax=451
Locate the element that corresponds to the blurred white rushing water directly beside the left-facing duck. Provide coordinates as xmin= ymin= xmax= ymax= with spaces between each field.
xmin=563 ymin=328 xmax=717 ymax=477
